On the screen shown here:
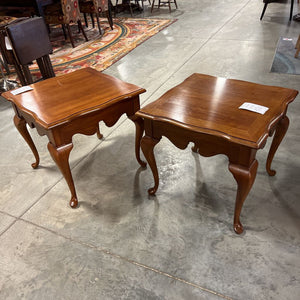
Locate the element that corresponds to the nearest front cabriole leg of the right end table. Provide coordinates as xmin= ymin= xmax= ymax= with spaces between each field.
xmin=228 ymin=159 xmax=258 ymax=234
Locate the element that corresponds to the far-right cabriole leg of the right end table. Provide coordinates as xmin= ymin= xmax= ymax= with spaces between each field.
xmin=266 ymin=116 xmax=290 ymax=176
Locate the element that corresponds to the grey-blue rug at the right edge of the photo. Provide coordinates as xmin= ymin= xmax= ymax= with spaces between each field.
xmin=271 ymin=37 xmax=300 ymax=75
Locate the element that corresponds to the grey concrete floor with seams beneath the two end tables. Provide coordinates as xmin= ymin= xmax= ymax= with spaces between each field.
xmin=0 ymin=0 xmax=300 ymax=300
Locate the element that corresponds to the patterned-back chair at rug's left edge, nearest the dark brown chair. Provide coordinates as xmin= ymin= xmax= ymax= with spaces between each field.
xmin=44 ymin=0 xmax=88 ymax=48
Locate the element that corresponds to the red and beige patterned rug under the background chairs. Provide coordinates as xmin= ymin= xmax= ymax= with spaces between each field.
xmin=9 ymin=18 xmax=175 ymax=79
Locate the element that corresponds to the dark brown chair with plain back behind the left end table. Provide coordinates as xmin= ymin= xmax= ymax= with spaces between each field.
xmin=6 ymin=17 xmax=55 ymax=85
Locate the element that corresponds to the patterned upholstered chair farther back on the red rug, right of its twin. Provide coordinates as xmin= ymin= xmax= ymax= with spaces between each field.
xmin=79 ymin=0 xmax=113 ymax=34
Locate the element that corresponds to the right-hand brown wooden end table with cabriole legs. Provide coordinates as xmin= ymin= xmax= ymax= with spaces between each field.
xmin=136 ymin=74 xmax=298 ymax=233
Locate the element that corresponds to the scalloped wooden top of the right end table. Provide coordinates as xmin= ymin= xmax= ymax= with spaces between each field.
xmin=136 ymin=73 xmax=298 ymax=148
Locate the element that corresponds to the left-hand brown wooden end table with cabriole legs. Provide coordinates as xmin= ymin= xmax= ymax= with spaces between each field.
xmin=2 ymin=68 xmax=146 ymax=208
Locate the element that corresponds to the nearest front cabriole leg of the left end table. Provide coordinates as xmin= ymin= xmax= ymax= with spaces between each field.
xmin=48 ymin=142 xmax=78 ymax=208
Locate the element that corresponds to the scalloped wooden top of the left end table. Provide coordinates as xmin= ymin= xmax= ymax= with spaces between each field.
xmin=2 ymin=68 xmax=146 ymax=129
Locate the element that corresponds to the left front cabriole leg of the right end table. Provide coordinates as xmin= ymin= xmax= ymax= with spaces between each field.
xmin=141 ymin=136 xmax=159 ymax=195
